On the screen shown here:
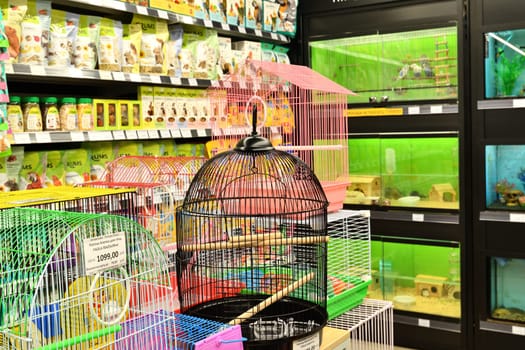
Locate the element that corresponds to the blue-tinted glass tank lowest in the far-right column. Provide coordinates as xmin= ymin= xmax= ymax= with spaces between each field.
xmin=490 ymin=257 xmax=525 ymax=322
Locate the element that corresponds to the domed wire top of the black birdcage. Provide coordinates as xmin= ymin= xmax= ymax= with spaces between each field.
xmin=182 ymin=136 xmax=328 ymax=215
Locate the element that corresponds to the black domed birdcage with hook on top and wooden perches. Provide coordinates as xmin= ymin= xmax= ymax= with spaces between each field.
xmin=176 ymin=100 xmax=328 ymax=349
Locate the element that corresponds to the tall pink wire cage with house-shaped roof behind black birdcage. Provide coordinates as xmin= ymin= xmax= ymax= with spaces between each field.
xmin=208 ymin=61 xmax=354 ymax=212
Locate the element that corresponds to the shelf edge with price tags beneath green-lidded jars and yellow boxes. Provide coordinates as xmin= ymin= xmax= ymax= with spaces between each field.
xmin=13 ymin=128 xmax=211 ymax=145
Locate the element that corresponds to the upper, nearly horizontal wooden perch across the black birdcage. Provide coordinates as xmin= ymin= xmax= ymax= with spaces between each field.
xmin=178 ymin=236 xmax=329 ymax=252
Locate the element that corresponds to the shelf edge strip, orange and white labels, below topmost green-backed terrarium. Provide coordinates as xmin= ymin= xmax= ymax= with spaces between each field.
xmin=346 ymin=103 xmax=459 ymax=117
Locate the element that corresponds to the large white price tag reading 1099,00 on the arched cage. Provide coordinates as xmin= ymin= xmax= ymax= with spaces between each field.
xmin=82 ymin=232 xmax=127 ymax=275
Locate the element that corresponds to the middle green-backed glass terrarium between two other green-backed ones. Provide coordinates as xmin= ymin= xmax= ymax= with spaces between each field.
xmin=345 ymin=134 xmax=459 ymax=210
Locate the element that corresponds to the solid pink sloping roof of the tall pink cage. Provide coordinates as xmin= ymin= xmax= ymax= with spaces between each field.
xmin=250 ymin=61 xmax=356 ymax=95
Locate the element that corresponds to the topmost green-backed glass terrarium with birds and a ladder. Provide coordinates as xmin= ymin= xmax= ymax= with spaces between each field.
xmin=309 ymin=26 xmax=458 ymax=103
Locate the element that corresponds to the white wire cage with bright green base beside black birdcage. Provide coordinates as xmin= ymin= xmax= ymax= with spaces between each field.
xmin=327 ymin=210 xmax=372 ymax=319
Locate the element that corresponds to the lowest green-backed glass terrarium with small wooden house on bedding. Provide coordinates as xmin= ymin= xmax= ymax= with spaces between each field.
xmin=367 ymin=239 xmax=461 ymax=318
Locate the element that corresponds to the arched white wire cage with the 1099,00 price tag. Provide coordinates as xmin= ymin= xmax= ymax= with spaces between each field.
xmin=0 ymin=208 xmax=173 ymax=349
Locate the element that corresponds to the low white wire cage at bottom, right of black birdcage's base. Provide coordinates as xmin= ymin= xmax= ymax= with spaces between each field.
xmin=327 ymin=298 xmax=394 ymax=350
